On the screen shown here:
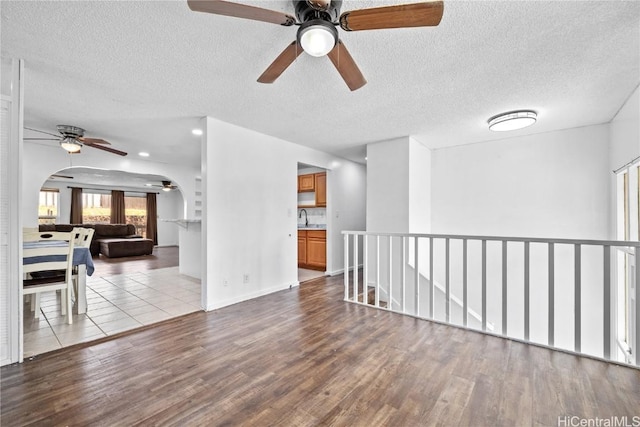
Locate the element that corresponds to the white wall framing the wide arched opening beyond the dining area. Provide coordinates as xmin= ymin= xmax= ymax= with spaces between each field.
xmin=22 ymin=143 xmax=200 ymax=229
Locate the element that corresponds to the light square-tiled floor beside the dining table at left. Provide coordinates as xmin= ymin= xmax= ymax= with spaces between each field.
xmin=24 ymin=267 xmax=201 ymax=359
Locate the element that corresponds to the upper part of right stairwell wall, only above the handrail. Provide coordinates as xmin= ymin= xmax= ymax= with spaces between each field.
xmin=431 ymin=125 xmax=611 ymax=239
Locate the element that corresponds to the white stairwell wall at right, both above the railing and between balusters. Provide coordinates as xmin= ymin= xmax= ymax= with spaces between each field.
xmin=432 ymin=125 xmax=611 ymax=354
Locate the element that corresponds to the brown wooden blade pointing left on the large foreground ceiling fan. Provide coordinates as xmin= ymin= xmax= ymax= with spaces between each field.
xmin=187 ymin=0 xmax=296 ymax=27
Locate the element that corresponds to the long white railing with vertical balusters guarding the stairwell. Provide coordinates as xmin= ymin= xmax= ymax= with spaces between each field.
xmin=343 ymin=231 xmax=640 ymax=366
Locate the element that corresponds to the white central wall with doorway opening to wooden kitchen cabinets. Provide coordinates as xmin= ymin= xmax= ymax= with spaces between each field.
xmin=202 ymin=118 xmax=365 ymax=309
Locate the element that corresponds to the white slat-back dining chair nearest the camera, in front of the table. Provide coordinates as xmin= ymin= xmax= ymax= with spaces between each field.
xmin=22 ymin=228 xmax=81 ymax=324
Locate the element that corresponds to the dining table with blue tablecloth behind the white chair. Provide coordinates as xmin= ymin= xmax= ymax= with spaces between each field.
xmin=22 ymin=240 xmax=95 ymax=314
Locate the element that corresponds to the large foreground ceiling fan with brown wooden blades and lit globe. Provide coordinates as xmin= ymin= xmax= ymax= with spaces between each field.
xmin=187 ymin=0 xmax=444 ymax=91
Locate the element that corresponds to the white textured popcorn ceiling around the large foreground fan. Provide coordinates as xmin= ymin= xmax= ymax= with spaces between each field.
xmin=0 ymin=0 xmax=640 ymax=164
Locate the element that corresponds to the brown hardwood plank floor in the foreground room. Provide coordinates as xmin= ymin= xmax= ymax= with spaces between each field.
xmin=0 ymin=276 xmax=640 ymax=426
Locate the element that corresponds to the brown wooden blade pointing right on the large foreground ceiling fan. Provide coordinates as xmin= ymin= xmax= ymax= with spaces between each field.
xmin=340 ymin=1 xmax=444 ymax=31
